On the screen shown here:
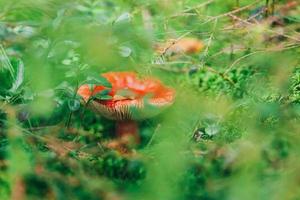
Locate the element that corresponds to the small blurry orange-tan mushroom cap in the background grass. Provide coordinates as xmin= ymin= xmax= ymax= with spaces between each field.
xmin=156 ymin=37 xmax=204 ymax=55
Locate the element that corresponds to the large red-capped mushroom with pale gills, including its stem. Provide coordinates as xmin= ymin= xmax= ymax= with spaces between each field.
xmin=77 ymin=72 xmax=175 ymax=144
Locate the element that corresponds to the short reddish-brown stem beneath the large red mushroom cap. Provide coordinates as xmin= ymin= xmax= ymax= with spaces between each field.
xmin=116 ymin=120 xmax=140 ymax=144
